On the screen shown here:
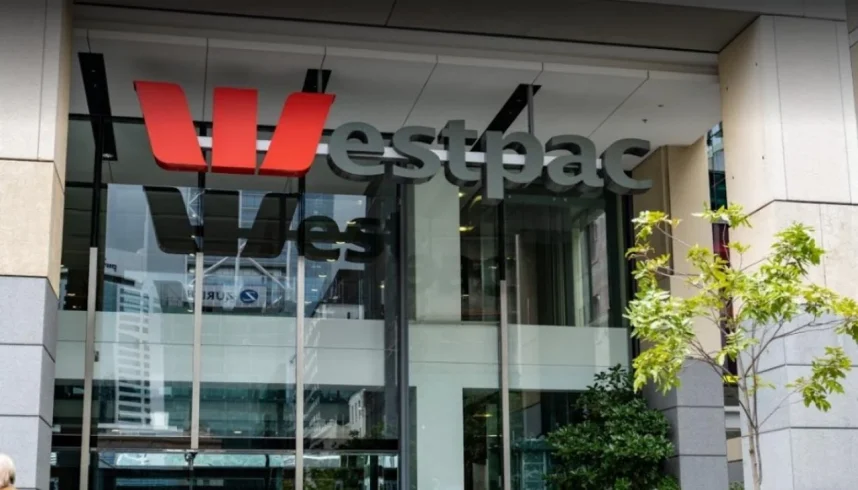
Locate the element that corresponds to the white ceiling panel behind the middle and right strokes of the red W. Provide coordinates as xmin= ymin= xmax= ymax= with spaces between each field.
xmin=205 ymin=40 xmax=325 ymax=125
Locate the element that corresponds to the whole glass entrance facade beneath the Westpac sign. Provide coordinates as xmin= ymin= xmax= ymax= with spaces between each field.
xmin=46 ymin=42 xmax=633 ymax=490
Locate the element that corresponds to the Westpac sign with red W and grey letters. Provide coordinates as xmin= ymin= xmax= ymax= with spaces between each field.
xmin=134 ymin=81 xmax=652 ymax=204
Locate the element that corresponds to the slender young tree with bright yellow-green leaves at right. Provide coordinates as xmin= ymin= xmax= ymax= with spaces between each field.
xmin=626 ymin=205 xmax=858 ymax=489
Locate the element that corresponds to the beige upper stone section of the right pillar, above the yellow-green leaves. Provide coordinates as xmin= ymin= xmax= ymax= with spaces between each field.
xmin=720 ymin=17 xmax=858 ymax=297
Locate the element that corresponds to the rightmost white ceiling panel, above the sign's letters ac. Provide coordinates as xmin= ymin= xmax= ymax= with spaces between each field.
xmin=592 ymin=72 xmax=721 ymax=157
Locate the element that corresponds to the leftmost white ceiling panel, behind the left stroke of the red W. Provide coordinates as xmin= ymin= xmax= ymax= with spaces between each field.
xmin=89 ymin=31 xmax=206 ymax=119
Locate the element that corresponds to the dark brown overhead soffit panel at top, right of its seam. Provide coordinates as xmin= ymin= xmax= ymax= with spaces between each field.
xmin=387 ymin=0 xmax=756 ymax=52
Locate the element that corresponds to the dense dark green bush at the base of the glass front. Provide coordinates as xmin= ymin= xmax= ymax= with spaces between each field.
xmin=547 ymin=366 xmax=679 ymax=490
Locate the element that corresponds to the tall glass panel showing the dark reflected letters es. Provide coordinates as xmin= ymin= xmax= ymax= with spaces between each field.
xmin=301 ymin=174 xmax=399 ymax=489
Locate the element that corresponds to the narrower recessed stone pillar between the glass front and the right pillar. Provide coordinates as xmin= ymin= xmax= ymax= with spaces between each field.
xmin=634 ymin=138 xmax=728 ymax=490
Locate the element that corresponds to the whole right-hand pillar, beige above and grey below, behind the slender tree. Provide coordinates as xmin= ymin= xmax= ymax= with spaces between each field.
xmin=719 ymin=16 xmax=858 ymax=490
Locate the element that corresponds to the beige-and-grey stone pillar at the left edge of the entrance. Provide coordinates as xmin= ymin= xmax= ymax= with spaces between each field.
xmin=0 ymin=0 xmax=71 ymax=490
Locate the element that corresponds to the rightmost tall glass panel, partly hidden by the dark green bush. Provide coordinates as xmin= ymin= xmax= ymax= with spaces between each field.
xmin=503 ymin=192 xmax=628 ymax=489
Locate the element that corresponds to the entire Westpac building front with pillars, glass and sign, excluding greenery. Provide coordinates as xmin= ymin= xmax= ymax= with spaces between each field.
xmin=5 ymin=0 xmax=858 ymax=490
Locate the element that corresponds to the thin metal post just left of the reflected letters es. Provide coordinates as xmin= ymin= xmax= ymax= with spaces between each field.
xmin=295 ymin=177 xmax=307 ymax=490
